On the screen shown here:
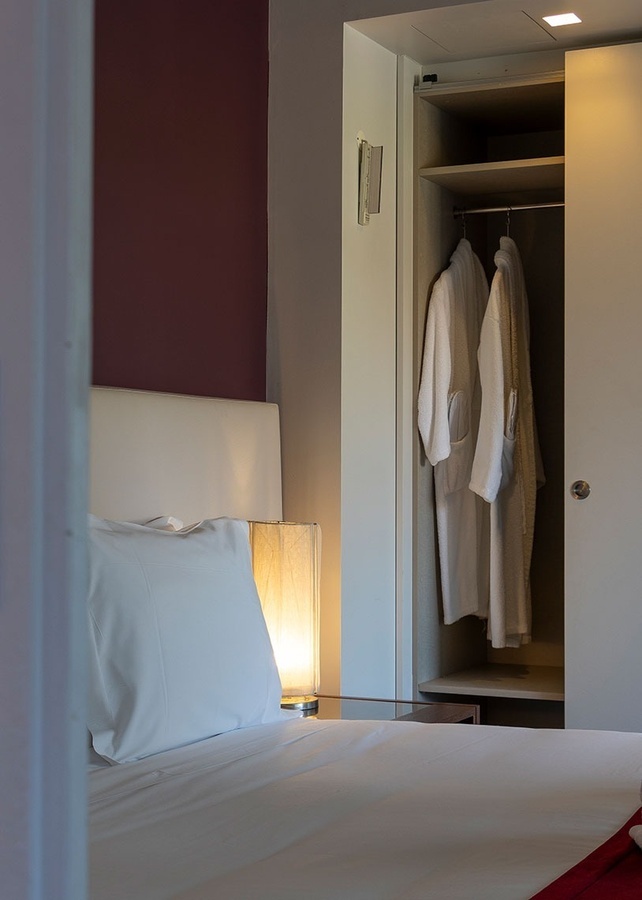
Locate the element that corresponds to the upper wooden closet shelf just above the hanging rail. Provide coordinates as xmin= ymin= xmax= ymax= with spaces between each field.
xmin=419 ymin=156 xmax=564 ymax=196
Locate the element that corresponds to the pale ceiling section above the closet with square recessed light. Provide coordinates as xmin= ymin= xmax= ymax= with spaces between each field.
xmin=351 ymin=0 xmax=642 ymax=65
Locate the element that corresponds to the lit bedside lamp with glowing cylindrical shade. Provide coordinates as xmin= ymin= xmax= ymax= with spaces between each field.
xmin=250 ymin=522 xmax=321 ymax=710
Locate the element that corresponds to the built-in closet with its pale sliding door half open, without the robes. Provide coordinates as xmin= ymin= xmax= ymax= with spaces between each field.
xmin=415 ymin=44 xmax=642 ymax=730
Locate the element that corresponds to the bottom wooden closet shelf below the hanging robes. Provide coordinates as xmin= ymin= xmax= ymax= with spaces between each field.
xmin=419 ymin=663 xmax=564 ymax=701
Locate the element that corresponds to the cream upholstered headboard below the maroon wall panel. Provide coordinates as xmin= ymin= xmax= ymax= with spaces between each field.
xmin=89 ymin=387 xmax=282 ymax=525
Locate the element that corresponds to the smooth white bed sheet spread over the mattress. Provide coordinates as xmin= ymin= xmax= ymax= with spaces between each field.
xmin=89 ymin=719 xmax=642 ymax=900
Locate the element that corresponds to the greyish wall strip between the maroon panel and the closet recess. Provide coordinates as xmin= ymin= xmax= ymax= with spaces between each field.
xmin=267 ymin=0 xmax=484 ymax=692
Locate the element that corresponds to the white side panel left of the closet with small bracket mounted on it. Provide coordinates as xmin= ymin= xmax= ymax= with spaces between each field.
xmin=341 ymin=26 xmax=397 ymax=697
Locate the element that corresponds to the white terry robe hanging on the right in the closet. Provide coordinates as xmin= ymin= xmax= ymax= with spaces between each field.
xmin=470 ymin=237 xmax=544 ymax=647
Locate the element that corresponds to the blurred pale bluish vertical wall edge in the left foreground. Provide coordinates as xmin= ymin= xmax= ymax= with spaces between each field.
xmin=0 ymin=0 xmax=92 ymax=900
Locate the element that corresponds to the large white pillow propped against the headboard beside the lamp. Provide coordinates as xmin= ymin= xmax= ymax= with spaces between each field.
xmin=88 ymin=516 xmax=282 ymax=762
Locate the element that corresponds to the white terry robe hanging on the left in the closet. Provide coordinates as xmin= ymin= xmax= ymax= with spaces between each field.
xmin=418 ymin=239 xmax=489 ymax=625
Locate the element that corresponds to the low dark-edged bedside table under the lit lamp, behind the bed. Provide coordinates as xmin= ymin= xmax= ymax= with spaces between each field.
xmin=310 ymin=694 xmax=479 ymax=725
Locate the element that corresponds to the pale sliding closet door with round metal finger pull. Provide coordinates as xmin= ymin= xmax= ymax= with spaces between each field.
xmin=566 ymin=44 xmax=642 ymax=731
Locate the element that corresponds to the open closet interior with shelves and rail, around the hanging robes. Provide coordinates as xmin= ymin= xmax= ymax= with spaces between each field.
xmin=414 ymin=72 xmax=564 ymax=727
